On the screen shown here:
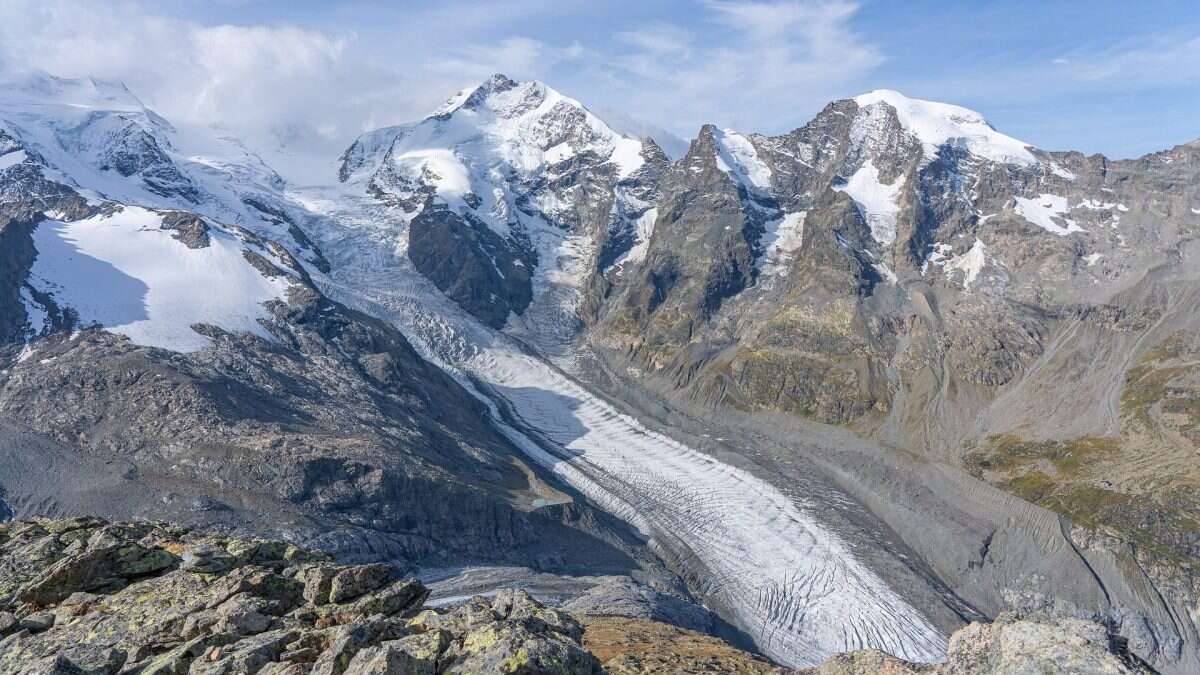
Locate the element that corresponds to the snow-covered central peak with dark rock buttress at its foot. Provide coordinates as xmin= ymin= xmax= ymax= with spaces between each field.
xmin=338 ymin=74 xmax=667 ymax=334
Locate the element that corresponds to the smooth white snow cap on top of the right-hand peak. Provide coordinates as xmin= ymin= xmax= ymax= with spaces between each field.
xmin=854 ymin=89 xmax=1038 ymax=166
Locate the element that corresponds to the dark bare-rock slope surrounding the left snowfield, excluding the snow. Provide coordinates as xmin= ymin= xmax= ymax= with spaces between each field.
xmin=0 ymin=145 xmax=654 ymax=590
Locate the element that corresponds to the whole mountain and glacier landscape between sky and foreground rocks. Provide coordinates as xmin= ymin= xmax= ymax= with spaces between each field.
xmin=0 ymin=74 xmax=1200 ymax=675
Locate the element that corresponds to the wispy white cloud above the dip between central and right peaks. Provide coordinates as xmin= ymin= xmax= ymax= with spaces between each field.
xmin=596 ymin=1 xmax=883 ymax=137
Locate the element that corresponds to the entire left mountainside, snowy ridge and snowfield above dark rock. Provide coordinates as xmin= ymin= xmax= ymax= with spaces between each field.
xmin=0 ymin=72 xmax=667 ymax=583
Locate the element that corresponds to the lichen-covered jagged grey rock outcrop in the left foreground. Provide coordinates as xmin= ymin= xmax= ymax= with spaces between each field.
xmin=0 ymin=518 xmax=602 ymax=675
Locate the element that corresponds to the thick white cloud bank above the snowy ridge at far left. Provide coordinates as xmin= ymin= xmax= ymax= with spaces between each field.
xmin=0 ymin=0 xmax=382 ymax=147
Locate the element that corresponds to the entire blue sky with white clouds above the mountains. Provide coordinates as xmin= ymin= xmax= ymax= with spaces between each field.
xmin=0 ymin=0 xmax=1200 ymax=157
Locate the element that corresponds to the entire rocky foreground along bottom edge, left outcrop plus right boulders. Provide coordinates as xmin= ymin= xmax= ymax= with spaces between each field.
xmin=0 ymin=518 xmax=1150 ymax=675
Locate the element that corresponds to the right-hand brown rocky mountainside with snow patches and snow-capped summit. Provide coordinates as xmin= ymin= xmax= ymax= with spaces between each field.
xmin=583 ymin=91 xmax=1200 ymax=670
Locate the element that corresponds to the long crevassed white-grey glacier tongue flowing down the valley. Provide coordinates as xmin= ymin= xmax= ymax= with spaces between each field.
xmin=307 ymin=192 xmax=947 ymax=667
